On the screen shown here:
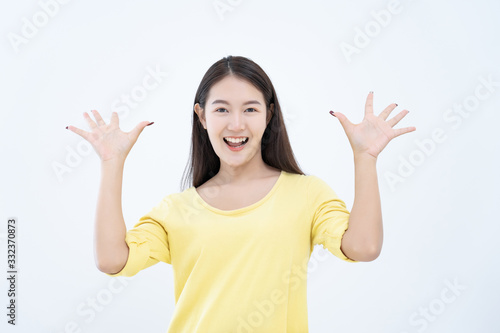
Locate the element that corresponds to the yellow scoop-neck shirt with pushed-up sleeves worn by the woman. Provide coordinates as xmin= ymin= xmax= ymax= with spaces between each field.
xmin=107 ymin=171 xmax=356 ymax=333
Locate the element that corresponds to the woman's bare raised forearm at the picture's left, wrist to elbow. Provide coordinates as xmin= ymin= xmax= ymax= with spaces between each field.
xmin=94 ymin=161 xmax=129 ymax=273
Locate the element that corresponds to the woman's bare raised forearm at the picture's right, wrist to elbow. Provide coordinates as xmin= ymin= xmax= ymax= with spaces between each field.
xmin=342 ymin=154 xmax=383 ymax=261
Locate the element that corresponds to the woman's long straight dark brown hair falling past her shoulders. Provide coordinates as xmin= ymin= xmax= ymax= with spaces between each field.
xmin=181 ymin=56 xmax=304 ymax=191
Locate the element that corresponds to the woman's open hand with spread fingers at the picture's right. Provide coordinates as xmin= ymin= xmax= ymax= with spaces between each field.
xmin=330 ymin=92 xmax=416 ymax=158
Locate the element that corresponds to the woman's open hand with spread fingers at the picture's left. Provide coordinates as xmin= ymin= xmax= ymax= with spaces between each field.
xmin=67 ymin=110 xmax=153 ymax=162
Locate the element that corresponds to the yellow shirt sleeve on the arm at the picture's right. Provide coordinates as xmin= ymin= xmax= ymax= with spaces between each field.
xmin=307 ymin=175 xmax=357 ymax=262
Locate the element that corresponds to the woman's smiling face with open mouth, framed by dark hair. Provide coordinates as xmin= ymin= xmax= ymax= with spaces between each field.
xmin=195 ymin=75 xmax=268 ymax=168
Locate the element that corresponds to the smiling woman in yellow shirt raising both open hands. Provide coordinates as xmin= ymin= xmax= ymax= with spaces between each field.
xmin=68 ymin=56 xmax=415 ymax=333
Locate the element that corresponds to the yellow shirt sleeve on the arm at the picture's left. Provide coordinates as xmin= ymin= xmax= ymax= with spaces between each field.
xmin=105 ymin=199 xmax=171 ymax=276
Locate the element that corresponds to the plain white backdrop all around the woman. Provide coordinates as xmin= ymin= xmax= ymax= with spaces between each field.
xmin=0 ymin=0 xmax=500 ymax=333
